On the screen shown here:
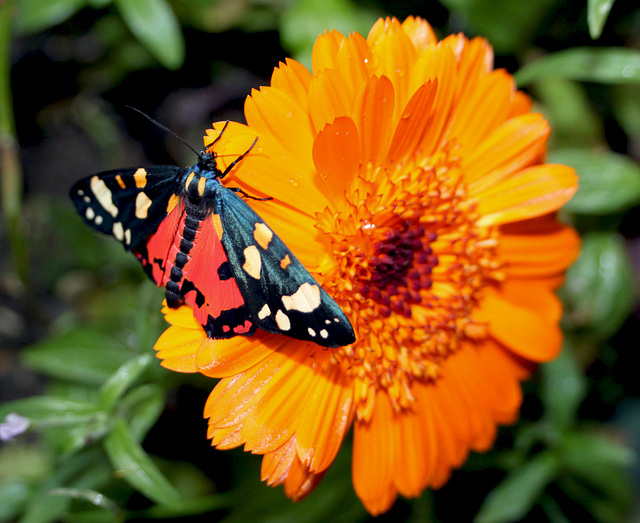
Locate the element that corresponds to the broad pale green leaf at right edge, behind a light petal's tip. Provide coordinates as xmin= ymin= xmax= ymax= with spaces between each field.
xmin=549 ymin=149 xmax=640 ymax=215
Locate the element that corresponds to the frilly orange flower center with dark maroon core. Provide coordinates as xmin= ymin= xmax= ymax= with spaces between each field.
xmin=318 ymin=150 xmax=503 ymax=419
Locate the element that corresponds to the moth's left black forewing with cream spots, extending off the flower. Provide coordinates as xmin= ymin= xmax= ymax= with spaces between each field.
xmin=69 ymin=166 xmax=182 ymax=251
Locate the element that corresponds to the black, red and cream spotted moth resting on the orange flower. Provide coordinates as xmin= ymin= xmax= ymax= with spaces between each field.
xmin=70 ymin=122 xmax=355 ymax=347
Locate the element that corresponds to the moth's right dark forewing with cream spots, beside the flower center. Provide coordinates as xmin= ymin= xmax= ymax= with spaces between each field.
xmin=213 ymin=188 xmax=355 ymax=347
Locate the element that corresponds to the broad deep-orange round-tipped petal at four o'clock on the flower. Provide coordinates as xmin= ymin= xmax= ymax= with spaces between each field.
xmin=475 ymin=289 xmax=562 ymax=363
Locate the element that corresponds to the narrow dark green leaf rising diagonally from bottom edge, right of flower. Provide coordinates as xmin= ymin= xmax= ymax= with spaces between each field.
xmin=474 ymin=452 xmax=560 ymax=523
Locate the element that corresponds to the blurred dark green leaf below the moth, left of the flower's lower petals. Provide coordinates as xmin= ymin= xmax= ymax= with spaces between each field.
xmin=23 ymin=329 xmax=132 ymax=385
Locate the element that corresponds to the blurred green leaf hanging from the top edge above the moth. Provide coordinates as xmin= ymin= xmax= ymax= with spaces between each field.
xmin=115 ymin=0 xmax=185 ymax=69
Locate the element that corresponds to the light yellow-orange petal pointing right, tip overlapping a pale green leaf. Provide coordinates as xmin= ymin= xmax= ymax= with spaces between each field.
xmin=477 ymin=164 xmax=577 ymax=227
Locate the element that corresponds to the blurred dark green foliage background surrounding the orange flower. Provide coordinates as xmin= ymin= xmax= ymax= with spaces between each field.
xmin=0 ymin=0 xmax=640 ymax=523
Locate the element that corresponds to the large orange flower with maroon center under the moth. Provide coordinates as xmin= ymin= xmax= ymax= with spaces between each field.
xmin=156 ymin=18 xmax=579 ymax=514
